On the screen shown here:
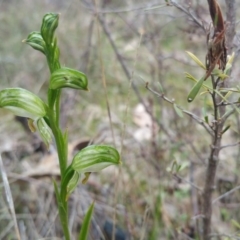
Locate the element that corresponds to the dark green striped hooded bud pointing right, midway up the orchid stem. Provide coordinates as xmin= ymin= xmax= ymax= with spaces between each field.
xmin=49 ymin=67 xmax=88 ymax=90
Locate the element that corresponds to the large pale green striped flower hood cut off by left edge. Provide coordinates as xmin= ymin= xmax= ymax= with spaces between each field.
xmin=0 ymin=88 xmax=47 ymax=120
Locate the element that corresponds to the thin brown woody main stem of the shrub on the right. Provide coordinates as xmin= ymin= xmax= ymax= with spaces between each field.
xmin=202 ymin=76 xmax=225 ymax=240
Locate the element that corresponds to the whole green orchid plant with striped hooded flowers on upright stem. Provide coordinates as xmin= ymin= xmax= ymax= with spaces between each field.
xmin=0 ymin=13 xmax=121 ymax=240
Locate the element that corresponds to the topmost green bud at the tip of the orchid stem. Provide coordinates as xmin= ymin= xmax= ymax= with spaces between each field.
xmin=41 ymin=13 xmax=59 ymax=45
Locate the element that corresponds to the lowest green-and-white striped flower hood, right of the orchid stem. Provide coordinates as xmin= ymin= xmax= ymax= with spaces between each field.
xmin=71 ymin=145 xmax=121 ymax=173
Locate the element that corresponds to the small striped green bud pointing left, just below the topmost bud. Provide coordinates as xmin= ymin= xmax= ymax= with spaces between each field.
xmin=23 ymin=32 xmax=46 ymax=54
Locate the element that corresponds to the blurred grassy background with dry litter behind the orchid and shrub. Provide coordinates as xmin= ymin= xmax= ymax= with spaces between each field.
xmin=0 ymin=0 xmax=240 ymax=240
